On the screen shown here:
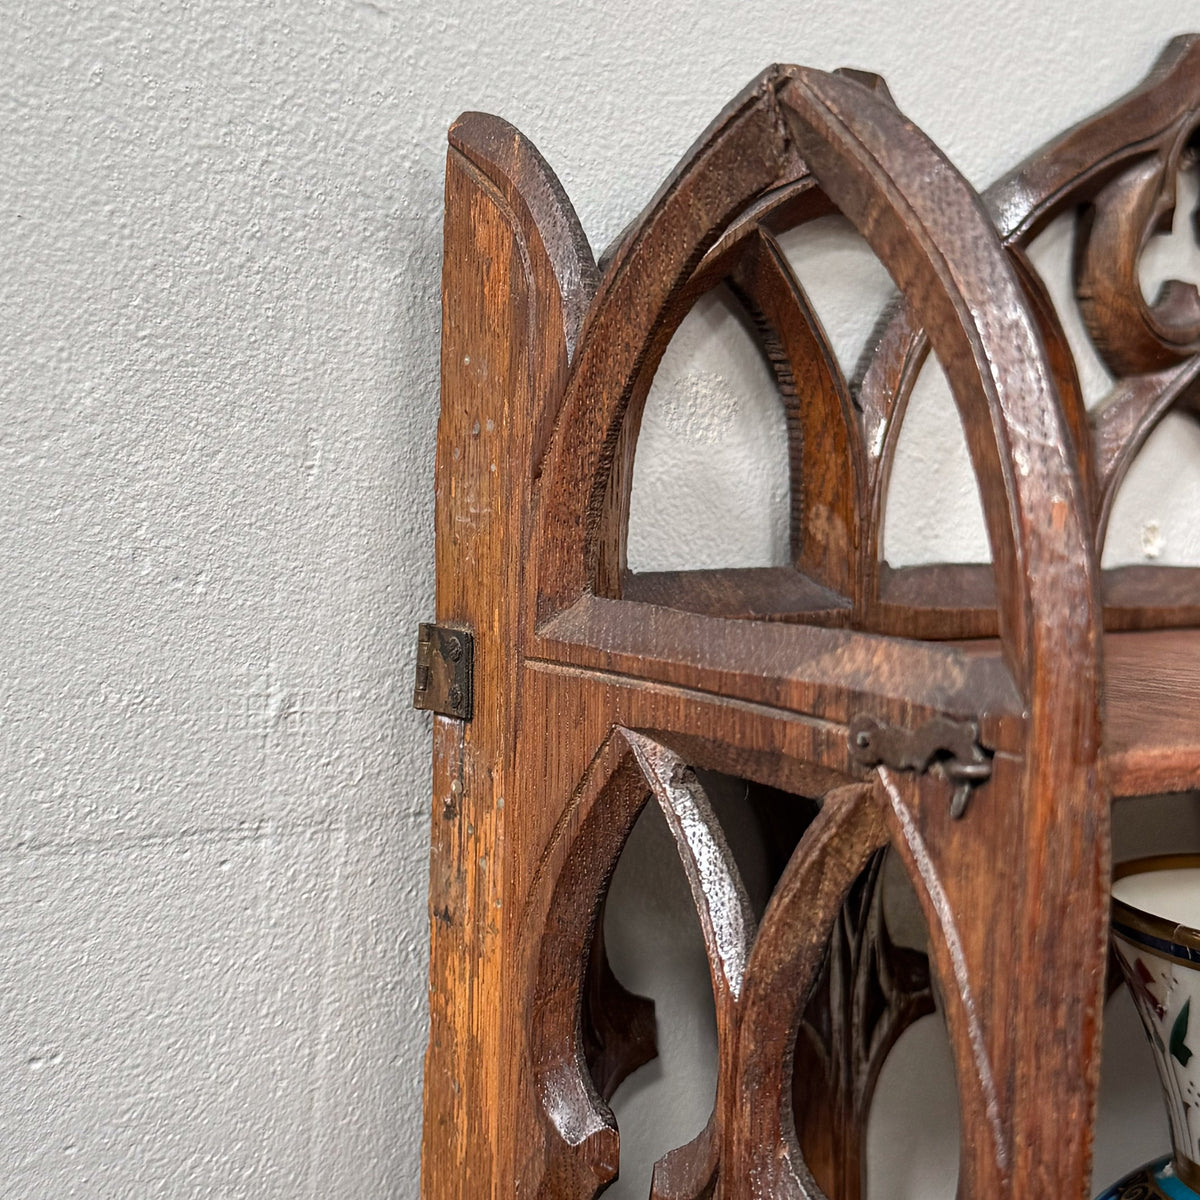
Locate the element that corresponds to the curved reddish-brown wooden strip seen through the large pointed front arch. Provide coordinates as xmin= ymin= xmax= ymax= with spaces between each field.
xmin=731 ymin=230 xmax=866 ymax=599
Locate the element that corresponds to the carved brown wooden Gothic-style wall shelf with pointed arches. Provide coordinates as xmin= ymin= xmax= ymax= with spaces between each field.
xmin=419 ymin=38 xmax=1200 ymax=1200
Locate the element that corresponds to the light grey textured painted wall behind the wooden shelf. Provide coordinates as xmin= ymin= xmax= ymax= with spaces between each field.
xmin=7 ymin=0 xmax=1200 ymax=1200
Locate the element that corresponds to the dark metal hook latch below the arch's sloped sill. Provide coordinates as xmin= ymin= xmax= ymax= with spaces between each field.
xmin=850 ymin=715 xmax=991 ymax=820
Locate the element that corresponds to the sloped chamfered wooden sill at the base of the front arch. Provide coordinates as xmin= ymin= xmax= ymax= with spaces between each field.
xmin=540 ymin=596 xmax=1024 ymax=749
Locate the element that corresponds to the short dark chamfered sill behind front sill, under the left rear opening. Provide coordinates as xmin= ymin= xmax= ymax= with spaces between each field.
xmin=622 ymin=566 xmax=851 ymax=625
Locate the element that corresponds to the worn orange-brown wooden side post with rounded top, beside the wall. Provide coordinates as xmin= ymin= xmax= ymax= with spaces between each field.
xmin=421 ymin=114 xmax=594 ymax=1200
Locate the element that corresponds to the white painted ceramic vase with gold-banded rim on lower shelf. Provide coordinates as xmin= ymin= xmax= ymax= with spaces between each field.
xmin=1100 ymin=854 xmax=1200 ymax=1200
